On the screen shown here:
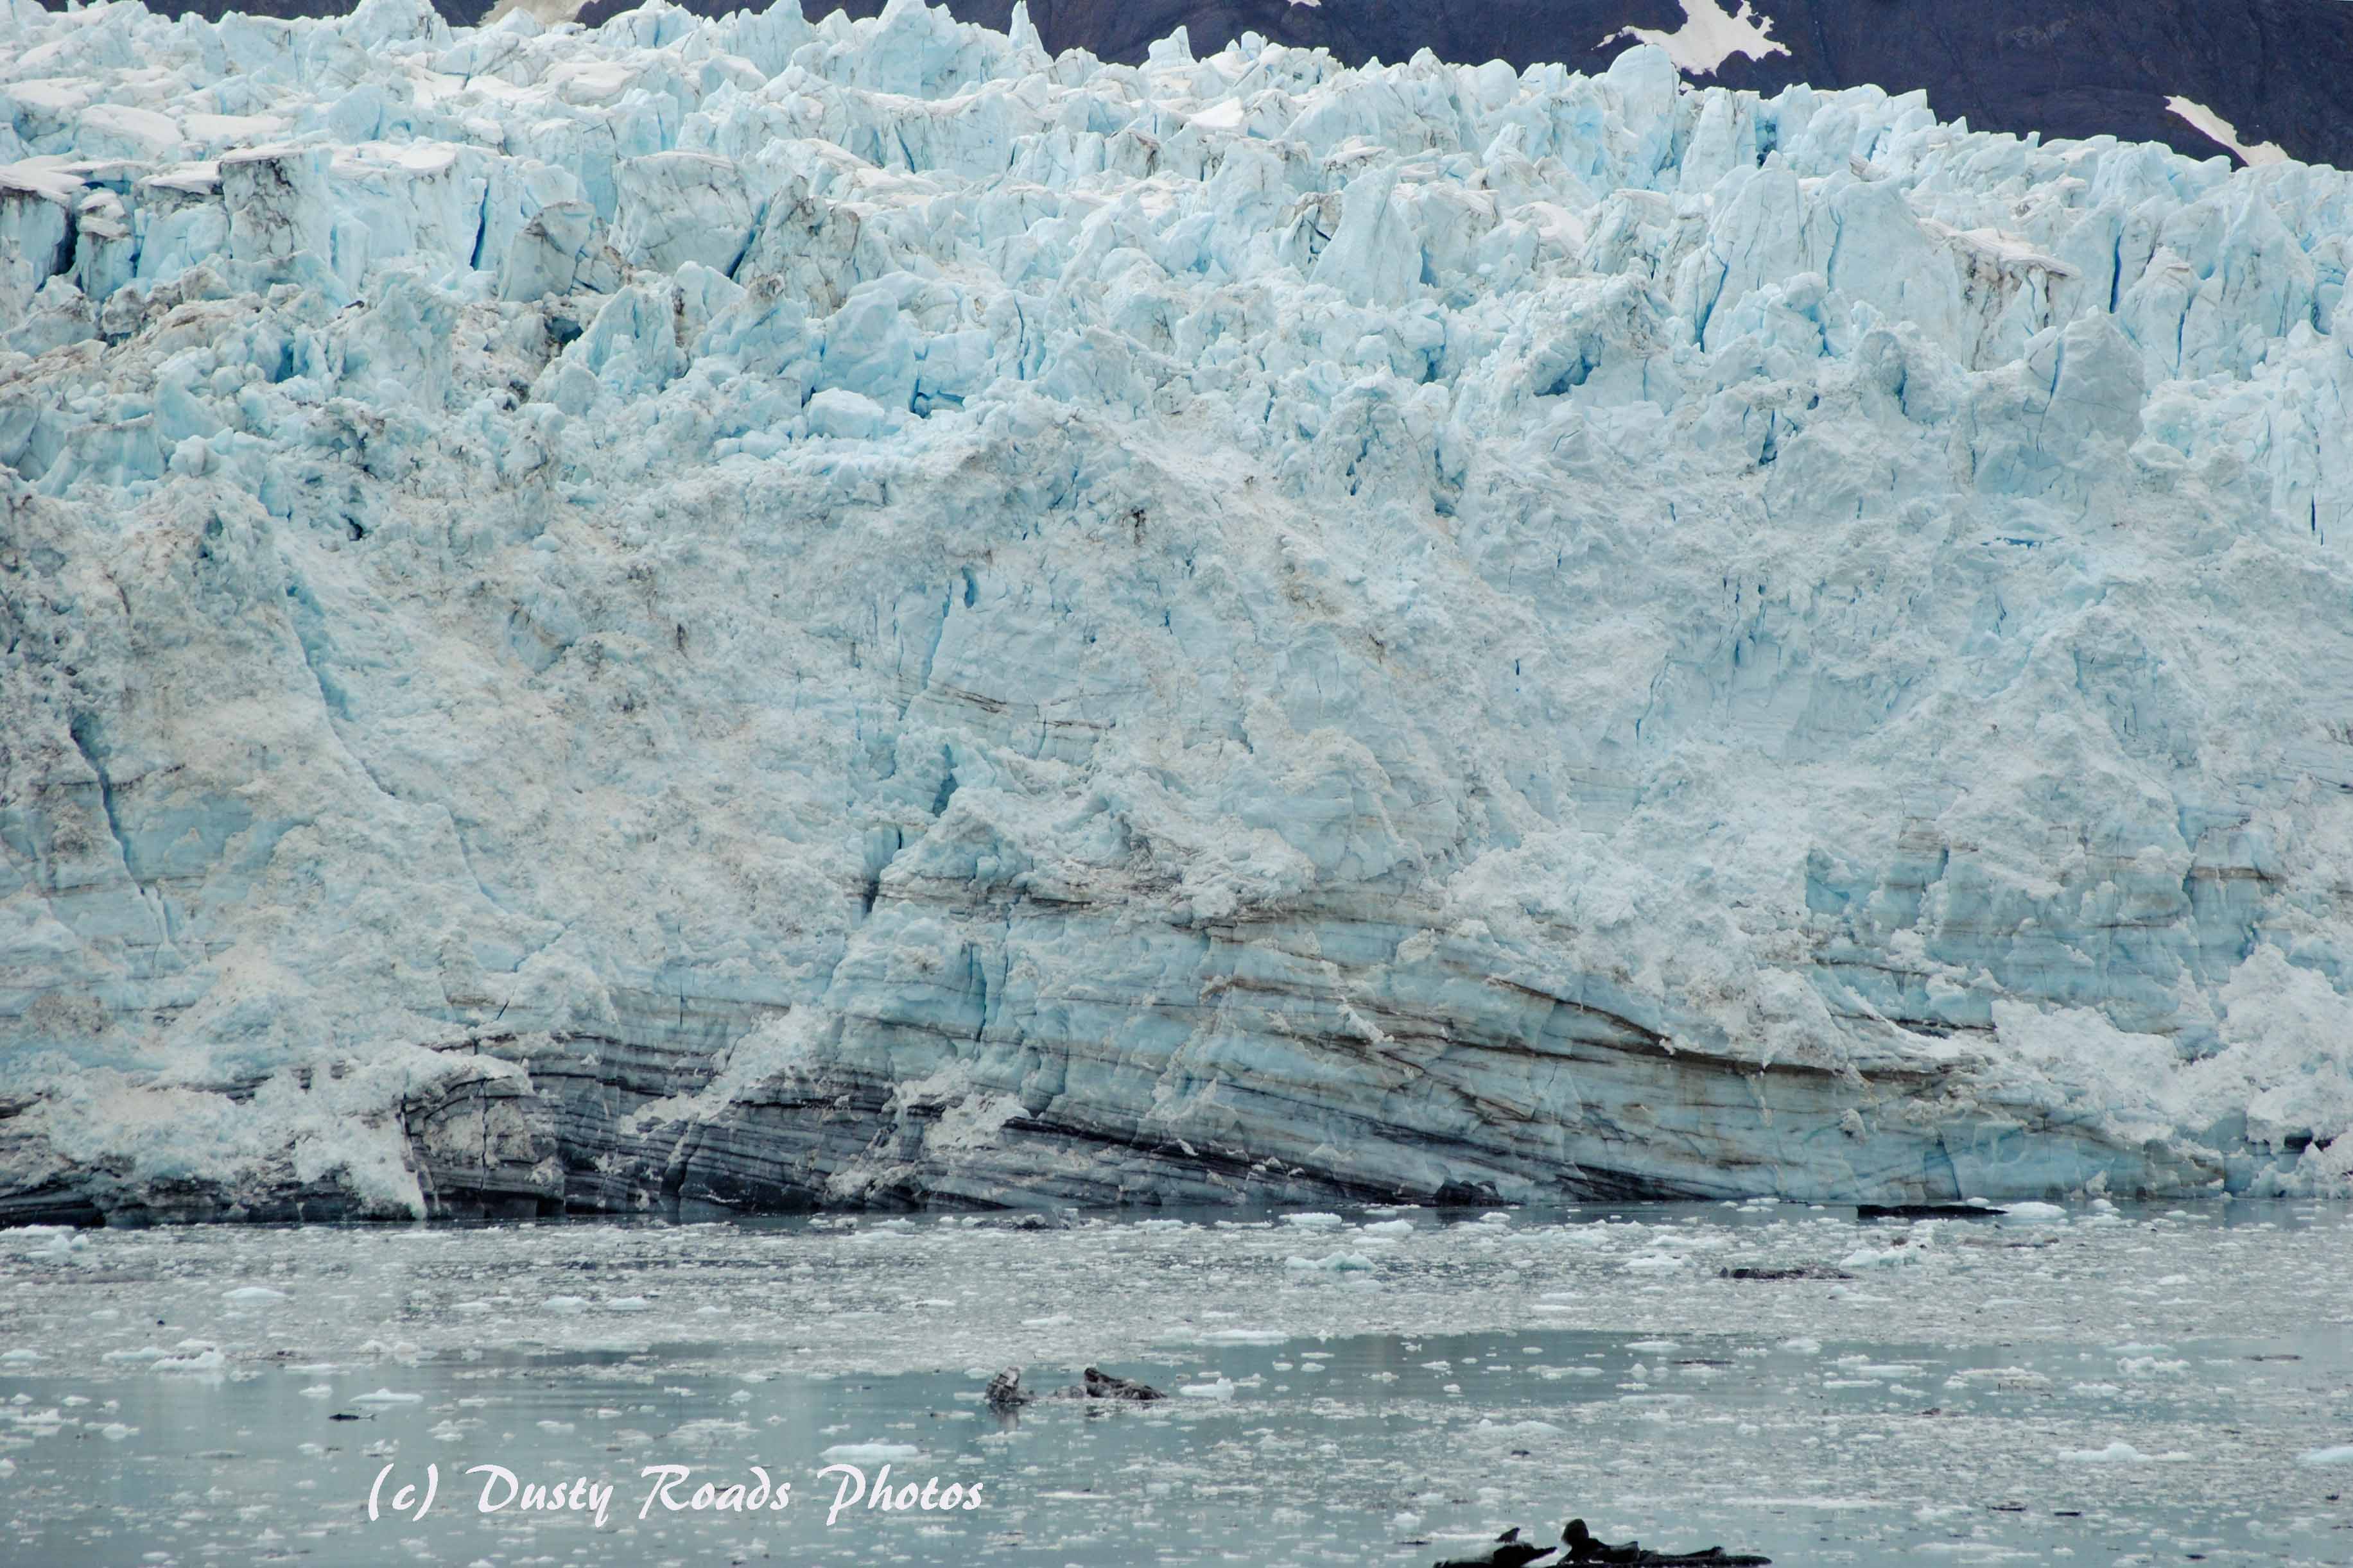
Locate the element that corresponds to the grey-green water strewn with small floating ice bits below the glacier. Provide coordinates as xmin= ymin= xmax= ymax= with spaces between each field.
xmin=0 ymin=1202 xmax=2353 ymax=1568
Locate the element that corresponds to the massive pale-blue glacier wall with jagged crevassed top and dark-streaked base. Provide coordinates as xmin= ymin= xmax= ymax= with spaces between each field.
xmin=0 ymin=0 xmax=2353 ymax=1225
